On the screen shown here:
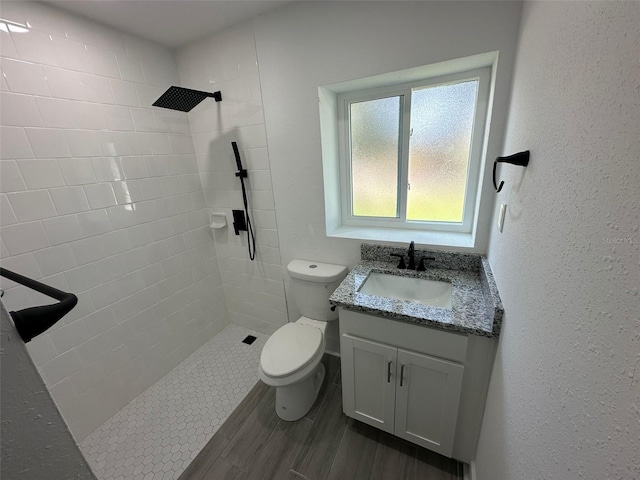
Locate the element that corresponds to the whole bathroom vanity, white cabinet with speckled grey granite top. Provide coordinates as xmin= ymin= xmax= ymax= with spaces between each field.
xmin=330 ymin=245 xmax=503 ymax=462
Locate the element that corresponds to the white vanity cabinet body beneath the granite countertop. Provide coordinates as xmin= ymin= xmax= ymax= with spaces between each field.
xmin=339 ymin=309 xmax=493 ymax=461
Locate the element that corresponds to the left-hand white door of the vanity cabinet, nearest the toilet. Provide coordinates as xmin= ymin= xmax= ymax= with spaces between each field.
xmin=340 ymin=333 xmax=397 ymax=433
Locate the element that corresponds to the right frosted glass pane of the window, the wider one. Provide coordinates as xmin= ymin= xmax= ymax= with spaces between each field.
xmin=407 ymin=80 xmax=478 ymax=222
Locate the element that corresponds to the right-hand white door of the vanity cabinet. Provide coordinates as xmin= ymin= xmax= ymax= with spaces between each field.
xmin=395 ymin=349 xmax=464 ymax=457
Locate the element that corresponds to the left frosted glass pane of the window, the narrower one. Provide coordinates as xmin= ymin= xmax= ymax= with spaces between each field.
xmin=351 ymin=96 xmax=401 ymax=218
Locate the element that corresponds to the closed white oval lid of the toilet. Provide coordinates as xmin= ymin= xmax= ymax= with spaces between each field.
xmin=260 ymin=323 xmax=322 ymax=377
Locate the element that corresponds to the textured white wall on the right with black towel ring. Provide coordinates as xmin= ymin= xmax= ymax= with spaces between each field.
xmin=477 ymin=2 xmax=640 ymax=480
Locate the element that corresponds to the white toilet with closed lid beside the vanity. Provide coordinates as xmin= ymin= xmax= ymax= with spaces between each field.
xmin=259 ymin=260 xmax=347 ymax=422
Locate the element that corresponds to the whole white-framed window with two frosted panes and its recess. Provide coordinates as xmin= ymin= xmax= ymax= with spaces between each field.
xmin=318 ymin=51 xmax=500 ymax=248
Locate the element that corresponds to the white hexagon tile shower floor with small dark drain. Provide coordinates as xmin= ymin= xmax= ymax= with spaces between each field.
xmin=80 ymin=325 xmax=267 ymax=480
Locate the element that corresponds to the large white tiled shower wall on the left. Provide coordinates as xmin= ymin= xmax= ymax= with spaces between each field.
xmin=0 ymin=2 xmax=229 ymax=440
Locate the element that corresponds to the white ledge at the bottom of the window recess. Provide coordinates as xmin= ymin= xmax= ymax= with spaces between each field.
xmin=327 ymin=226 xmax=475 ymax=250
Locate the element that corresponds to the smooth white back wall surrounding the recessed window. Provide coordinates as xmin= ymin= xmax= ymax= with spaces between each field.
xmin=255 ymin=2 xmax=520 ymax=344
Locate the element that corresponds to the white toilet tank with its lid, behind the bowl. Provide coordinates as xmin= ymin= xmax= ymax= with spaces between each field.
xmin=287 ymin=260 xmax=347 ymax=322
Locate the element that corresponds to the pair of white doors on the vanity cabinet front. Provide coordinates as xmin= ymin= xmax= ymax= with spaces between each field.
xmin=341 ymin=333 xmax=464 ymax=457
